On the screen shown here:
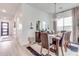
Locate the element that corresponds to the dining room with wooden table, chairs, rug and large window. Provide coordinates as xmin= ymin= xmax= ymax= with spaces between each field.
xmin=15 ymin=3 xmax=79 ymax=56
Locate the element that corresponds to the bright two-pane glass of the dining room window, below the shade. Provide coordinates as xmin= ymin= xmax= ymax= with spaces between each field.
xmin=57 ymin=17 xmax=72 ymax=31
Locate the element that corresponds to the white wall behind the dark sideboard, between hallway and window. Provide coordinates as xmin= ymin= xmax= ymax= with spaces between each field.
xmin=15 ymin=4 xmax=53 ymax=45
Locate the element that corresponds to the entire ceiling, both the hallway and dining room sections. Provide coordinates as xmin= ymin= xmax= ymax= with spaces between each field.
xmin=0 ymin=3 xmax=79 ymax=18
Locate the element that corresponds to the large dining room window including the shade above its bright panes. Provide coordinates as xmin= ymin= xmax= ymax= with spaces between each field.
xmin=57 ymin=10 xmax=72 ymax=31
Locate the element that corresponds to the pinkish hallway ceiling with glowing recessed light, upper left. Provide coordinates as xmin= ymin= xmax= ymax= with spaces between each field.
xmin=0 ymin=3 xmax=20 ymax=18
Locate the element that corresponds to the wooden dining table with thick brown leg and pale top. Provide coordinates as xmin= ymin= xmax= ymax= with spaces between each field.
xmin=48 ymin=34 xmax=60 ymax=55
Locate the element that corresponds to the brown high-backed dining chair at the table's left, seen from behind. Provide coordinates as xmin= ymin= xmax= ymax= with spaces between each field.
xmin=40 ymin=32 xmax=52 ymax=55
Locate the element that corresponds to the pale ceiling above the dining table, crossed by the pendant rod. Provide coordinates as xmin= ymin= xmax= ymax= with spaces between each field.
xmin=29 ymin=3 xmax=79 ymax=14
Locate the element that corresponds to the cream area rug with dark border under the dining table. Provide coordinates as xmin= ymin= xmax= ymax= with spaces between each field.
xmin=26 ymin=44 xmax=79 ymax=56
